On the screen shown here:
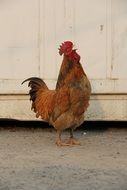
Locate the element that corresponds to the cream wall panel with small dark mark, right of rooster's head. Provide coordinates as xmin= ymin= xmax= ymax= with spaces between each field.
xmin=75 ymin=0 xmax=107 ymax=79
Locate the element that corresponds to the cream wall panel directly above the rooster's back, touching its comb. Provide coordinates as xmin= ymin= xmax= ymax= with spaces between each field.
xmin=40 ymin=0 xmax=74 ymax=80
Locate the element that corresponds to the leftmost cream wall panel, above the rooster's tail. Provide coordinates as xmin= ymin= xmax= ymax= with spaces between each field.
xmin=0 ymin=0 xmax=39 ymax=80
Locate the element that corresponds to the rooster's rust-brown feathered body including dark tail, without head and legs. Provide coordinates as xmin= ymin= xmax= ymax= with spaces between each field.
xmin=24 ymin=56 xmax=91 ymax=128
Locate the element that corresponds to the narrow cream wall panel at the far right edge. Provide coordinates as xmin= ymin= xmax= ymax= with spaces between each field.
xmin=111 ymin=0 xmax=127 ymax=79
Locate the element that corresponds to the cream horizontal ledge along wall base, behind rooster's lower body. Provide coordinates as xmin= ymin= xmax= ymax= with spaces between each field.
xmin=0 ymin=94 xmax=127 ymax=121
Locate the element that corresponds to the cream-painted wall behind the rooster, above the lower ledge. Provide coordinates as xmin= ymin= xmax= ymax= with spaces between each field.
xmin=0 ymin=0 xmax=127 ymax=119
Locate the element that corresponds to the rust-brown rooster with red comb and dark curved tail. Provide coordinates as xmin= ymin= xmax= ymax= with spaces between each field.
xmin=22 ymin=41 xmax=91 ymax=146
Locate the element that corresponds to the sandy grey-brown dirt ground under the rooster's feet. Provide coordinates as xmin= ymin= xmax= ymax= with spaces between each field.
xmin=0 ymin=126 xmax=127 ymax=190
